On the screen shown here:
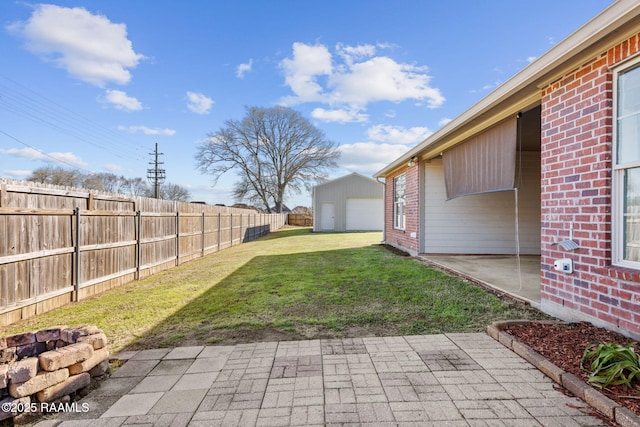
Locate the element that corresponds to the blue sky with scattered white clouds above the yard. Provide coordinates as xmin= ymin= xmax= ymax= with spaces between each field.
xmin=0 ymin=0 xmax=612 ymax=207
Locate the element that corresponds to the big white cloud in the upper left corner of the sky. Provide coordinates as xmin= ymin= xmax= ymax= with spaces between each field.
xmin=7 ymin=4 xmax=144 ymax=87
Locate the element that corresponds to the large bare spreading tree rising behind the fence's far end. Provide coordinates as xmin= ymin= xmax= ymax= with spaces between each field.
xmin=195 ymin=107 xmax=340 ymax=212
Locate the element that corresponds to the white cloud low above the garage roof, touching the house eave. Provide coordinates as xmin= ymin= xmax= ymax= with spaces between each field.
xmin=339 ymin=142 xmax=409 ymax=176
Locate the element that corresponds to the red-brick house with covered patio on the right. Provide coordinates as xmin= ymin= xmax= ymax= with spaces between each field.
xmin=375 ymin=0 xmax=640 ymax=339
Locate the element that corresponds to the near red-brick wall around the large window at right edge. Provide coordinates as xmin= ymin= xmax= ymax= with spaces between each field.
xmin=541 ymin=34 xmax=640 ymax=337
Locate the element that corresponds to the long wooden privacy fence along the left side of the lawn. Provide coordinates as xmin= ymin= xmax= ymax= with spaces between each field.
xmin=0 ymin=180 xmax=286 ymax=326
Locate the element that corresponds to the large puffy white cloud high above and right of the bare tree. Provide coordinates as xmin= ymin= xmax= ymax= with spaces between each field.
xmin=280 ymin=42 xmax=445 ymax=118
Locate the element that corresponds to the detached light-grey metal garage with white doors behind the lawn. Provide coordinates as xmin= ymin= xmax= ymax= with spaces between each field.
xmin=313 ymin=173 xmax=384 ymax=231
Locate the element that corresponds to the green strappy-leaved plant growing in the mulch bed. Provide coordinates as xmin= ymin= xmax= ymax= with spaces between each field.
xmin=580 ymin=343 xmax=640 ymax=388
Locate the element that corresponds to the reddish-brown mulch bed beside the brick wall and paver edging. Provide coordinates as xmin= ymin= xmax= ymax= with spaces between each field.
xmin=504 ymin=322 xmax=640 ymax=415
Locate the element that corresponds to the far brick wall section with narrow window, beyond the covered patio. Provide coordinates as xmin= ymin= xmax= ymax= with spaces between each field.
xmin=384 ymin=161 xmax=420 ymax=255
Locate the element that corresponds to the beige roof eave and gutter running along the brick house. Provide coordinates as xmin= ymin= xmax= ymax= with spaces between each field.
xmin=373 ymin=0 xmax=640 ymax=178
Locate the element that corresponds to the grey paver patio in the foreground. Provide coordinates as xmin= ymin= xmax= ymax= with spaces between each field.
xmin=37 ymin=333 xmax=607 ymax=427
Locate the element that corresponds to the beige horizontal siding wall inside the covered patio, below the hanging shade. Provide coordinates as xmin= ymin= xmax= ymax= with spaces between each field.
xmin=423 ymin=152 xmax=540 ymax=255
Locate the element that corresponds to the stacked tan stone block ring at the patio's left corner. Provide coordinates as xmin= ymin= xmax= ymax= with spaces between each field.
xmin=0 ymin=326 xmax=109 ymax=420
